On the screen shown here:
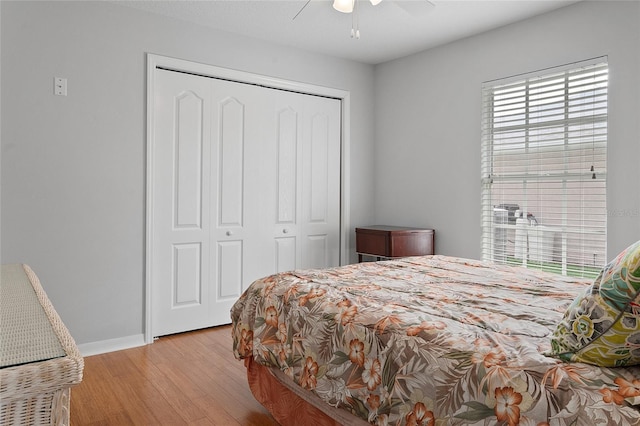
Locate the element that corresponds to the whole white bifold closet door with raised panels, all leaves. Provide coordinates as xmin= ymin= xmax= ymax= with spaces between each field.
xmin=150 ymin=70 xmax=341 ymax=336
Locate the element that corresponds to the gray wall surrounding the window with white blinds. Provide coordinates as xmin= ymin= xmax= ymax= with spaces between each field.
xmin=375 ymin=1 xmax=640 ymax=259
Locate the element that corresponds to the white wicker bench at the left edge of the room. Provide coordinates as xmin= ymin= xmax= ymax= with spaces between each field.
xmin=0 ymin=265 xmax=84 ymax=425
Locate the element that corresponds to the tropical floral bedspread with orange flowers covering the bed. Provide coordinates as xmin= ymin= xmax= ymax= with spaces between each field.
xmin=231 ymin=256 xmax=640 ymax=426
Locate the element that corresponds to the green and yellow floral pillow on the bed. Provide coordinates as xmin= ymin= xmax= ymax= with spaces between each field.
xmin=547 ymin=241 xmax=640 ymax=367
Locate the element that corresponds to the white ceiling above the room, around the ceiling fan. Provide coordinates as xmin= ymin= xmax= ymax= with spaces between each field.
xmin=113 ymin=0 xmax=579 ymax=64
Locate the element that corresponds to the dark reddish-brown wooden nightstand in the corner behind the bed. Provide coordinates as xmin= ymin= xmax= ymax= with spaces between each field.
xmin=356 ymin=225 xmax=435 ymax=262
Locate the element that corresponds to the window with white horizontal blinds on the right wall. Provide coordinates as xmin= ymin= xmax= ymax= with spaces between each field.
xmin=482 ymin=58 xmax=608 ymax=277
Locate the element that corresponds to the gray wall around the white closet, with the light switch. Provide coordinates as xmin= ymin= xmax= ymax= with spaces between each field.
xmin=0 ymin=1 xmax=374 ymax=344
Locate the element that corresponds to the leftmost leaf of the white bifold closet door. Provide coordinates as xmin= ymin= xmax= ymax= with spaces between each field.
xmin=150 ymin=71 xmax=211 ymax=336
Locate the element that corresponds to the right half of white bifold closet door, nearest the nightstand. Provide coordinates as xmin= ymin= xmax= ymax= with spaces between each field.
xmin=271 ymin=92 xmax=341 ymax=271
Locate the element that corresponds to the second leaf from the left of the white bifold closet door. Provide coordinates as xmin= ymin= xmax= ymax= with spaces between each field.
xmin=211 ymin=79 xmax=276 ymax=316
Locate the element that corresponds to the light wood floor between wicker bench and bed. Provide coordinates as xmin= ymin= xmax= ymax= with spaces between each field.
xmin=71 ymin=326 xmax=278 ymax=426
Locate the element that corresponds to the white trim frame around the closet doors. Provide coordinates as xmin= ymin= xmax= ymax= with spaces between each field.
xmin=144 ymin=53 xmax=351 ymax=343
